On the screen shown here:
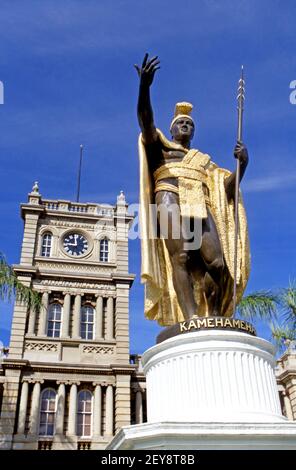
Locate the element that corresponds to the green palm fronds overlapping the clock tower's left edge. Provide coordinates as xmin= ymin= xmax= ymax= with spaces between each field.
xmin=0 ymin=253 xmax=41 ymax=310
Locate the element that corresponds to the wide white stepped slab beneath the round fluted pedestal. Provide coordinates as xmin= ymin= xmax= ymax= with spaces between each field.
xmin=106 ymin=422 xmax=296 ymax=450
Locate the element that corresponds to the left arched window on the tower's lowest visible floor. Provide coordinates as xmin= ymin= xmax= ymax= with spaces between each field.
xmin=39 ymin=388 xmax=57 ymax=436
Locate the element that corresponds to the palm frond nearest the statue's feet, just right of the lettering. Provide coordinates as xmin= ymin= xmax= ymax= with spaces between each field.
xmin=237 ymin=291 xmax=277 ymax=321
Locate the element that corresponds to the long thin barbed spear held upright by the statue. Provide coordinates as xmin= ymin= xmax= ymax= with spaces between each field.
xmin=233 ymin=65 xmax=245 ymax=316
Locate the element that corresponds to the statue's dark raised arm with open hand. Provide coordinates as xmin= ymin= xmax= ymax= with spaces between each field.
xmin=135 ymin=54 xmax=160 ymax=144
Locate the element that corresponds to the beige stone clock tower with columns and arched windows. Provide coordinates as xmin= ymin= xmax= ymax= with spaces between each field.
xmin=1 ymin=183 xmax=135 ymax=449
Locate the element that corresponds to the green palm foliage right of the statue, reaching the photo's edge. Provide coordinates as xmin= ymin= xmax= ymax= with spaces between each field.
xmin=237 ymin=281 xmax=296 ymax=351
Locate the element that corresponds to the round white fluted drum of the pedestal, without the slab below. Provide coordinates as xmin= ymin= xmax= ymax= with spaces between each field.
xmin=142 ymin=330 xmax=284 ymax=423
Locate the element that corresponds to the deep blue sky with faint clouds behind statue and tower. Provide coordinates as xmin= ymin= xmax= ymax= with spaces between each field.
xmin=0 ymin=0 xmax=296 ymax=352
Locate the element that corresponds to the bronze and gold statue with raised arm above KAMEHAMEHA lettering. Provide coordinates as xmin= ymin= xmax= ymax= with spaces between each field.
xmin=135 ymin=54 xmax=250 ymax=326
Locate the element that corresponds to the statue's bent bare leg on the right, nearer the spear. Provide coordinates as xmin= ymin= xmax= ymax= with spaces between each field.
xmin=200 ymin=210 xmax=224 ymax=316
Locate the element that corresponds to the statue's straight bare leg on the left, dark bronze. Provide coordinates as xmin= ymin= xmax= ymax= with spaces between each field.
xmin=155 ymin=191 xmax=197 ymax=320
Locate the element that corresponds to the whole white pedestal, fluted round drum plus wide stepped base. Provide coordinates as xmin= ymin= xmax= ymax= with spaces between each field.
xmin=107 ymin=330 xmax=296 ymax=450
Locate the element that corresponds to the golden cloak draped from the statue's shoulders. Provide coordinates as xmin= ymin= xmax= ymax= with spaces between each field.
xmin=139 ymin=130 xmax=250 ymax=326
